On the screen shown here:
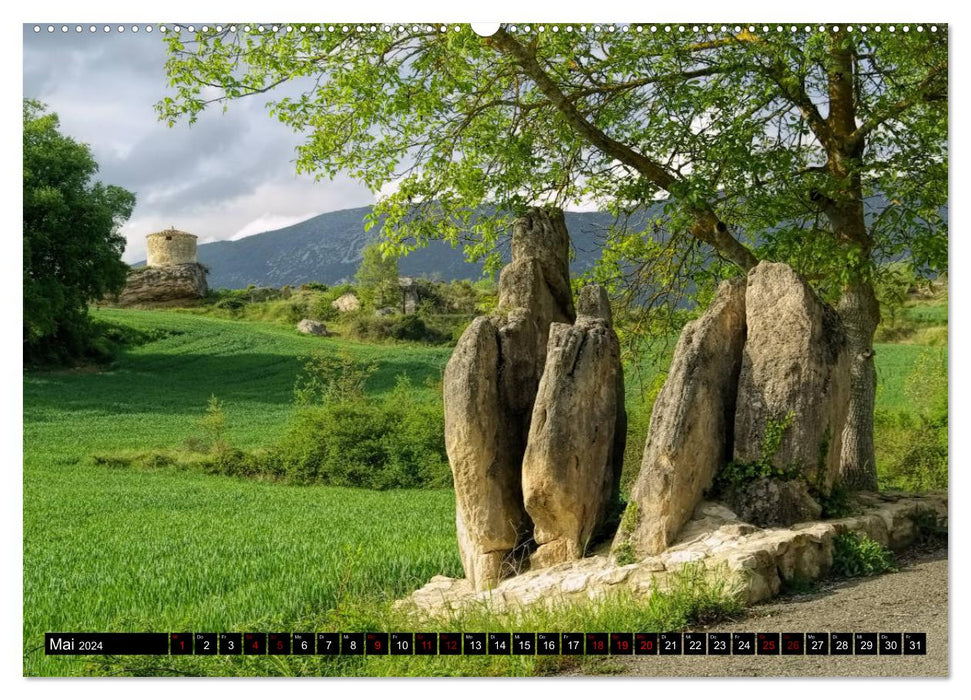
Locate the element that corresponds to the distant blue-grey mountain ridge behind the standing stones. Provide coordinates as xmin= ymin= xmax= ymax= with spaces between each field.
xmin=187 ymin=207 xmax=636 ymax=289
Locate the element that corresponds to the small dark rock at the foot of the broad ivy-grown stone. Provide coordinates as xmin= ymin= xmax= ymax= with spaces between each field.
xmin=726 ymin=478 xmax=823 ymax=527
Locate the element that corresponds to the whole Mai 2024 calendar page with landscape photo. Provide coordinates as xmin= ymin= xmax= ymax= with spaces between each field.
xmin=20 ymin=6 xmax=951 ymax=690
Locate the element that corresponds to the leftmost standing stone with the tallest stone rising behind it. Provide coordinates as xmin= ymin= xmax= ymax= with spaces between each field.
xmin=444 ymin=209 xmax=574 ymax=590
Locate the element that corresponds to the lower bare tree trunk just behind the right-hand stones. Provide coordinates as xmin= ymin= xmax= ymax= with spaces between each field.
xmin=839 ymin=281 xmax=880 ymax=491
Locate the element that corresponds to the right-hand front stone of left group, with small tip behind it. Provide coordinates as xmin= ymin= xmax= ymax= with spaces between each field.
xmin=522 ymin=285 xmax=625 ymax=568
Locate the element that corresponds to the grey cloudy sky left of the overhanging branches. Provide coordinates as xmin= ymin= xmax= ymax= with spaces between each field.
xmin=24 ymin=24 xmax=374 ymax=262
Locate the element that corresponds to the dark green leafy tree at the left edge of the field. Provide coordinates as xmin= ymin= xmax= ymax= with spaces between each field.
xmin=23 ymin=100 xmax=135 ymax=362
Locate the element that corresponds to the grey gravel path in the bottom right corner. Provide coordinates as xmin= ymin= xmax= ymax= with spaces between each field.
xmin=604 ymin=549 xmax=948 ymax=677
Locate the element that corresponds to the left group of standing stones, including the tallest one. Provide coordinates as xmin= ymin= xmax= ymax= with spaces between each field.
xmin=444 ymin=209 xmax=626 ymax=590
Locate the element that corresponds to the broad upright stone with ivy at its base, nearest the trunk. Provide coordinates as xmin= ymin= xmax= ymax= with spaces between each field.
xmin=734 ymin=262 xmax=849 ymax=493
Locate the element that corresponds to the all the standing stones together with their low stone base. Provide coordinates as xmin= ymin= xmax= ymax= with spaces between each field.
xmin=420 ymin=204 xmax=946 ymax=608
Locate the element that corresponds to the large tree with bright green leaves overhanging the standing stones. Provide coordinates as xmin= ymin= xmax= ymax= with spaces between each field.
xmin=159 ymin=25 xmax=948 ymax=488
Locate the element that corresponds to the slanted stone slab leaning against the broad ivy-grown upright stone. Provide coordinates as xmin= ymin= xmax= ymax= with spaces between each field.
xmin=615 ymin=280 xmax=745 ymax=556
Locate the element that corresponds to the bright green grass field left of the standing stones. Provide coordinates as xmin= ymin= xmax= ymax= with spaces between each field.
xmin=23 ymin=310 xmax=946 ymax=675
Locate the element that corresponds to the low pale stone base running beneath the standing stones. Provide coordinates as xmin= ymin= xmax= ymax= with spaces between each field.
xmin=396 ymin=494 xmax=948 ymax=619
